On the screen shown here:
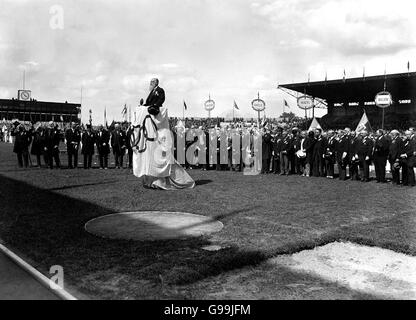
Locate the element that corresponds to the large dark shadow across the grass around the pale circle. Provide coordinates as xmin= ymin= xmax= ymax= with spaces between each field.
xmin=0 ymin=170 xmax=410 ymax=298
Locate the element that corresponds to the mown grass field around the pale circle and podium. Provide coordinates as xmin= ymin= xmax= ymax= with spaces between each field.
xmin=0 ymin=143 xmax=416 ymax=299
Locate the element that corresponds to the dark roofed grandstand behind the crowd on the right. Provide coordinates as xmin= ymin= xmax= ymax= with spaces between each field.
xmin=278 ymin=72 xmax=416 ymax=129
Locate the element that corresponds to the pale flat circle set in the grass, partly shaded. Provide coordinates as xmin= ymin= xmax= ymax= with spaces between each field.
xmin=85 ymin=211 xmax=223 ymax=241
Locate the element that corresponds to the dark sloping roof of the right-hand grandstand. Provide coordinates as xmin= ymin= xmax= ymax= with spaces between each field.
xmin=279 ymin=72 xmax=416 ymax=102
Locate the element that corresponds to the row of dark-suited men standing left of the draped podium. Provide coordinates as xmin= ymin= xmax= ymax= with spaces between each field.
xmin=12 ymin=122 xmax=133 ymax=169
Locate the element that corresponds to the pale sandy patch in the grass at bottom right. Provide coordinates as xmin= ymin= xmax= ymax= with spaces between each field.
xmin=271 ymin=242 xmax=416 ymax=299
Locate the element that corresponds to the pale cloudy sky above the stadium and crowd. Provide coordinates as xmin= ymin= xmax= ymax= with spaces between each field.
xmin=0 ymin=0 xmax=416 ymax=123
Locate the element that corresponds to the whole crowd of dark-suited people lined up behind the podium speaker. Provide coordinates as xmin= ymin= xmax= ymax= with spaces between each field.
xmin=1 ymin=118 xmax=416 ymax=186
